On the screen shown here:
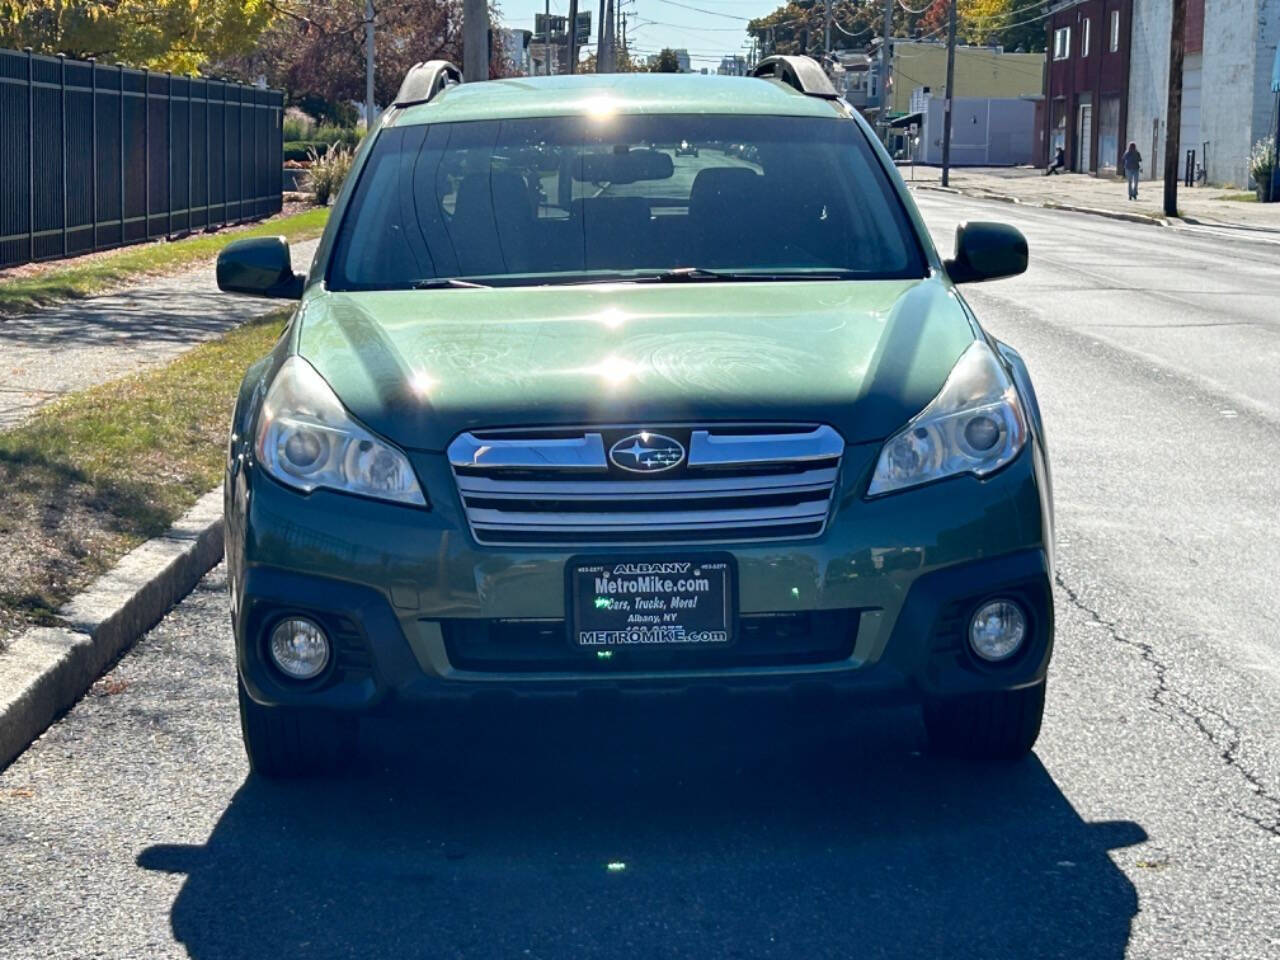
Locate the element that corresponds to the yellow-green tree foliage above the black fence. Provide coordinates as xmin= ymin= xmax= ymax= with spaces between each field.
xmin=0 ymin=0 xmax=275 ymax=73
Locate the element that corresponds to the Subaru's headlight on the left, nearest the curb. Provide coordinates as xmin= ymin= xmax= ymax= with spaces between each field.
xmin=255 ymin=356 xmax=426 ymax=507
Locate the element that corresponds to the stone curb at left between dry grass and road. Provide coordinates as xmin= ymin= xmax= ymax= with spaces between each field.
xmin=0 ymin=486 xmax=223 ymax=769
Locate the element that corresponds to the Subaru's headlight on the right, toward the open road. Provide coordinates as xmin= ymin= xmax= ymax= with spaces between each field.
xmin=867 ymin=340 xmax=1027 ymax=497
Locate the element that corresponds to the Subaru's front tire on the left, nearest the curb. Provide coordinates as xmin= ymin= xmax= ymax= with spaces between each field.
xmin=236 ymin=678 xmax=358 ymax=780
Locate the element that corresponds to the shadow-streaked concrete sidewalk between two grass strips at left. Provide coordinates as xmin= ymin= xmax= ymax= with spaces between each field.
xmin=0 ymin=239 xmax=319 ymax=430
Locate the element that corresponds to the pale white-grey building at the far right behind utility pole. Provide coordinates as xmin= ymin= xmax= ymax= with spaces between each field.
xmin=1128 ymin=0 xmax=1280 ymax=187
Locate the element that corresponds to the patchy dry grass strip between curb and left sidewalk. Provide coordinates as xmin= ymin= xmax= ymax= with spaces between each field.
xmin=0 ymin=311 xmax=288 ymax=640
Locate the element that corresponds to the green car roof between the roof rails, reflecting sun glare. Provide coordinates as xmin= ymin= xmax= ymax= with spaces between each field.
xmin=394 ymin=73 xmax=842 ymax=127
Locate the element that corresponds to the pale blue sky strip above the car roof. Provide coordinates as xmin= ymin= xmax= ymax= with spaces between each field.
xmin=499 ymin=0 xmax=781 ymax=73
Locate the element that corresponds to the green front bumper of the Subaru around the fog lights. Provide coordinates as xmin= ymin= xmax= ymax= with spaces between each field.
xmin=227 ymin=435 xmax=1053 ymax=710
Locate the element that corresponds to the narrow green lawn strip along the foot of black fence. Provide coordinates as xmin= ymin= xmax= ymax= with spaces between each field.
xmin=0 ymin=207 xmax=329 ymax=314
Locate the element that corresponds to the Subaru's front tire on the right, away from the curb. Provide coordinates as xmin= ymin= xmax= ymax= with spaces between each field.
xmin=924 ymin=680 xmax=1044 ymax=763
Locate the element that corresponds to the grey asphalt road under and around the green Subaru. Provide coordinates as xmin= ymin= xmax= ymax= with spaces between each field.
xmin=0 ymin=193 xmax=1280 ymax=960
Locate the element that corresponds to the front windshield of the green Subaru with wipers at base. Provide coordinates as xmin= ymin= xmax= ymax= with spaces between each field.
xmin=326 ymin=115 xmax=924 ymax=291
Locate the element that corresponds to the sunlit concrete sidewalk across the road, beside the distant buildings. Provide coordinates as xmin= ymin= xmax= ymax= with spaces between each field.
xmin=899 ymin=165 xmax=1280 ymax=233
